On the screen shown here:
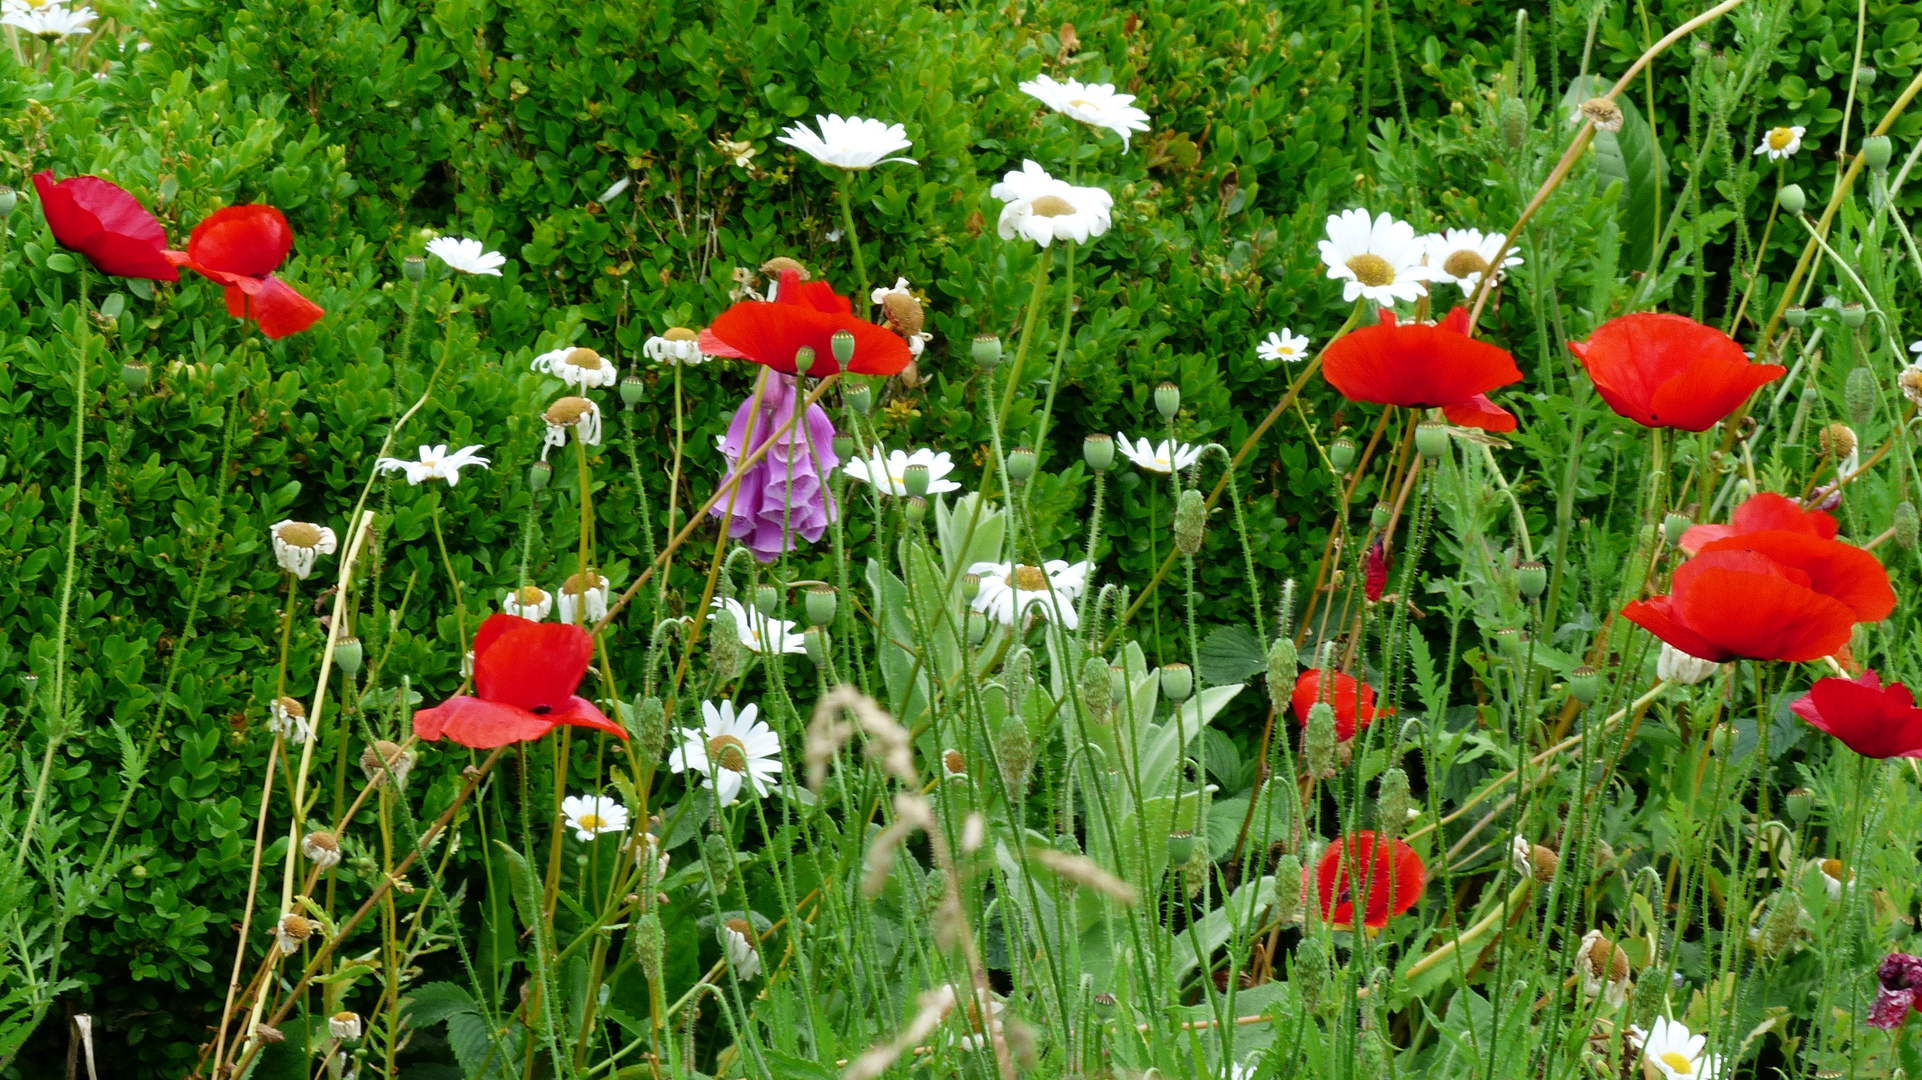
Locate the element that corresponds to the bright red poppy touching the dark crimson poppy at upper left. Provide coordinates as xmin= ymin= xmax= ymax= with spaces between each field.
xmin=171 ymin=204 xmax=327 ymax=340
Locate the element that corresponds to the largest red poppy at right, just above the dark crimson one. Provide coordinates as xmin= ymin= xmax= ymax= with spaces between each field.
xmin=1622 ymin=530 xmax=1895 ymax=661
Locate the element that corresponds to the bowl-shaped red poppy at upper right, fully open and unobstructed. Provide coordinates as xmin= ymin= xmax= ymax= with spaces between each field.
xmin=1568 ymin=311 xmax=1787 ymax=430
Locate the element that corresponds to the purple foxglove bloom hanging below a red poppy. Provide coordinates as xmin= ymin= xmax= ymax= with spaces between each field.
xmin=707 ymin=369 xmax=840 ymax=563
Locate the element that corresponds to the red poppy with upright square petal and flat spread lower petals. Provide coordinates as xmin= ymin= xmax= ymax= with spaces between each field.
xmin=413 ymin=615 xmax=627 ymax=749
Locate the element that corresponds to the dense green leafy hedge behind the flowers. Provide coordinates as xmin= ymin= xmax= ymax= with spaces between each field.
xmin=0 ymin=0 xmax=1922 ymax=1076
